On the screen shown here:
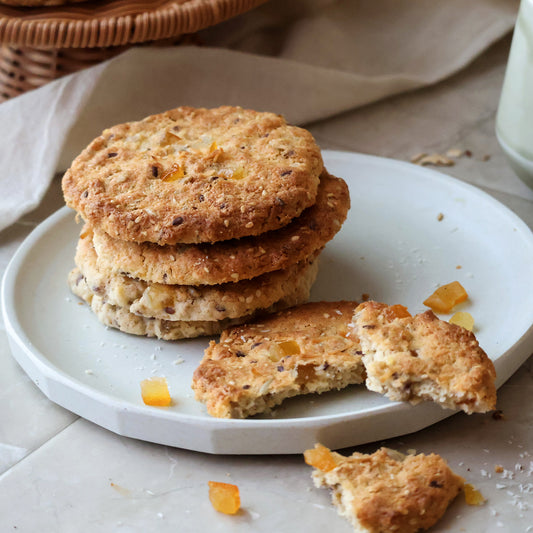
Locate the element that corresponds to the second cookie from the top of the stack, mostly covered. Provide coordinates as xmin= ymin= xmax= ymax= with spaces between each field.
xmin=93 ymin=171 xmax=350 ymax=285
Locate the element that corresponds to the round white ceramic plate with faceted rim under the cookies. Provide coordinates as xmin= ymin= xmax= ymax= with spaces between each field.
xmin=2 ymin=151 xmax=533 ymax=454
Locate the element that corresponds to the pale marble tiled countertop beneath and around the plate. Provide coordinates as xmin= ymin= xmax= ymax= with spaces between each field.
xmin=0 ymin=35 xmax=533 ymax=533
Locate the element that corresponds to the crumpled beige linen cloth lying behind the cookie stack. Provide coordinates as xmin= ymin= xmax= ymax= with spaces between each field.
xmin=0 ymin=0 xmax=518 ymax=229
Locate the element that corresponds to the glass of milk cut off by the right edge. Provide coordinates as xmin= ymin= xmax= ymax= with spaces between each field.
xmin=496 ymin=0 xmax=533 ymax=188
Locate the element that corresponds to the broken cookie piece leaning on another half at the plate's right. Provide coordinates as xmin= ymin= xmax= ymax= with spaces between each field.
xmin=353 ymin=302 xmax=496 ymax=413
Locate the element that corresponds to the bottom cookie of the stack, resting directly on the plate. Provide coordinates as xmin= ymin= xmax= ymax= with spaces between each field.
xmin=68 ymin=268 xmax=308 ymax=341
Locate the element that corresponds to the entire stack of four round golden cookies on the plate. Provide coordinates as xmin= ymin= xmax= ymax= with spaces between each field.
xmin=63 ymin=106 xmax=349 ymax=339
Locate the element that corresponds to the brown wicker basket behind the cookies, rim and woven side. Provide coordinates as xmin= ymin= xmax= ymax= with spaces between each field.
xmin=0 ymin=0 xmax=266 ymax=101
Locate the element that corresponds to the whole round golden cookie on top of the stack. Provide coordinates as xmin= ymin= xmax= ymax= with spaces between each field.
xmin=62 ymin=106 xmax=323 ymax=245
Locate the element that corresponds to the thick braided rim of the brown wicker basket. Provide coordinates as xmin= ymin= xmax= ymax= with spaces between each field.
xmin=0 ymin=0 xmax=267 ymax=48
